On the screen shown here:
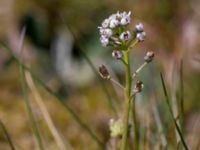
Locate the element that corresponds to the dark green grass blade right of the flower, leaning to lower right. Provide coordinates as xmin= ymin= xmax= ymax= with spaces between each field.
xmin=160 ymin=73 xmax=189 ymax=150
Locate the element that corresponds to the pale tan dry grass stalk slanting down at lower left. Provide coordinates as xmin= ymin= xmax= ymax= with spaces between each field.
xmin=25 ymin=72 xmax=72 ymax=150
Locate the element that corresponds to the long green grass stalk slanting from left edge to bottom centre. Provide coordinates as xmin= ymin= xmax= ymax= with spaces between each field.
xmin=1 ymin=43 xmax=104 ymax=148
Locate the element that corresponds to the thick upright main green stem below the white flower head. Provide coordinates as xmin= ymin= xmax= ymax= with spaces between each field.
xmin=121 ymin=50 xmax=132 ymax=150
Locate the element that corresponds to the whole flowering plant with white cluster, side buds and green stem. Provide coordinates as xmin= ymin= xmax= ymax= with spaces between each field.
xmin=98 ymin=12 xmax=154 ymax=150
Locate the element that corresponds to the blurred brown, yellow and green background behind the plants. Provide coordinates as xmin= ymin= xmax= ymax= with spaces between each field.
xmin=0 ymin=0 xmax=200 ymax=150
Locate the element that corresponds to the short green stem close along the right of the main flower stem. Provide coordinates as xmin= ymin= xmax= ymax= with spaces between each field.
xmin=131 ymin=96 xmax=139 ymax=150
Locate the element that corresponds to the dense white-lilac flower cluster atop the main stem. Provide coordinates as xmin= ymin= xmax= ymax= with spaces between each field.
xmin=98 ymin=12 xmax=131 ymax=47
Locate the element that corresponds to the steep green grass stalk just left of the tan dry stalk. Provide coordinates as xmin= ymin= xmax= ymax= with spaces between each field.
xmin=19 ymin=64 xmax=44 ymax=150
